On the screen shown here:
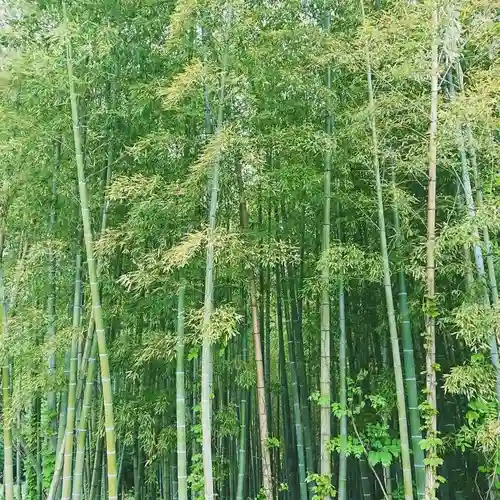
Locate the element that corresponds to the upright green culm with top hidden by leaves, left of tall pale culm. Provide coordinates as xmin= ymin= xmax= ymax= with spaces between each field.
xmin=175 ymin=280 xmax=188 ymax=500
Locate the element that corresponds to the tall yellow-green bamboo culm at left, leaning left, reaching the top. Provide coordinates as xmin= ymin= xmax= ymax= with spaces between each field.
xmin=64 ymin=5 xmax=118 ymax=500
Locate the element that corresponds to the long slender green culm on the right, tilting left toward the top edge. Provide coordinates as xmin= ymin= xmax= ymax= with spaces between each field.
xmin=361 ymin=0 xmax=413 ymax=500
